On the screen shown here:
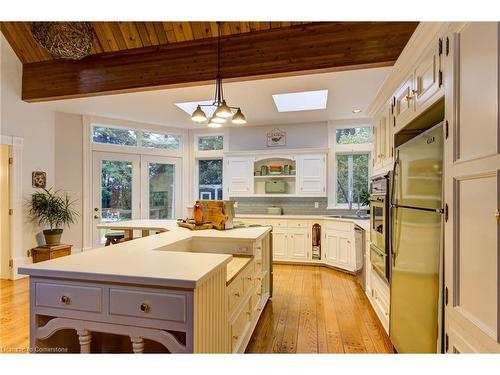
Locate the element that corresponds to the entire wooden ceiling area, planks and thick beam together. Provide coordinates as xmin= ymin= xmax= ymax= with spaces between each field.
xmin=1 ymin=22 xmax=418 ymax=102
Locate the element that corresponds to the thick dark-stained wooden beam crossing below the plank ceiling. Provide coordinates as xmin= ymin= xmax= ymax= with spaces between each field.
xmin=22 ymin=22 xmax=418 ymax=102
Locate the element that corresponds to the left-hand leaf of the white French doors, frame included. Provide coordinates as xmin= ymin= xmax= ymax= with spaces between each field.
xmin=92 ymin=151 xmax=140 ymax=247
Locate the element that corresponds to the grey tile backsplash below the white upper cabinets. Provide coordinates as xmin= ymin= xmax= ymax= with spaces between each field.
xmin=231 ymin=197 xmax=365 ymax=215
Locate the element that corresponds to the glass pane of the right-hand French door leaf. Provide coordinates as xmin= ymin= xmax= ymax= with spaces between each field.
xmin=149 ymin=163 xmax=175 ymax=219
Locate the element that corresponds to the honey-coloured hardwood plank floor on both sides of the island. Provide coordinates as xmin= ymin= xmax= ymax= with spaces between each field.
xmin=0 ymin=265 xmax=392 ymax=353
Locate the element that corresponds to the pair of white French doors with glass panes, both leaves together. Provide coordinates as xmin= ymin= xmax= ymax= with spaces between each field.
xmin=92 ymin=151 xmax=182 ymax=247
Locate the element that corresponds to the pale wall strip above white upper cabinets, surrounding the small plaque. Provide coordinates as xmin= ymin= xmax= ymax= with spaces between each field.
xmin=229 ymin=122 xmax=328 ymax=151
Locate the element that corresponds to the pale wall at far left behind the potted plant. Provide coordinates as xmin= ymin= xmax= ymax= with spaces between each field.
xmin=0 ymin=35 xmax=55 ymax=276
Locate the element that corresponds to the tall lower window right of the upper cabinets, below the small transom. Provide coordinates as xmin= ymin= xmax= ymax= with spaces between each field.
xmin=336 ymin=153 xmax=369 ymax=207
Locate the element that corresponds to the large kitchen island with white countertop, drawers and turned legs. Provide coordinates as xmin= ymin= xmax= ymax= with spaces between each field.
xmin=19 ymin=220 xmax=272 ymax=353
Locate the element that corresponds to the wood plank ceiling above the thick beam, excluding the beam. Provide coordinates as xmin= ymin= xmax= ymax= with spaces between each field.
xmin=0 ymin=22 xmax=310 ymax=64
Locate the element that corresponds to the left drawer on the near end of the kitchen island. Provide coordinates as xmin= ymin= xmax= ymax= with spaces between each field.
xmin=35 ymin=283 xmax=102 ymax=313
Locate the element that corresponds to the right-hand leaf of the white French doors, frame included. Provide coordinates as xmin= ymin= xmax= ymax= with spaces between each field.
xmin=141 ymin=155 xmax=182 ymax=220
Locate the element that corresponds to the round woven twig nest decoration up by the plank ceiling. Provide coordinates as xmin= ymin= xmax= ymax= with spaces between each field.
xmin=31 ymin=22 xmax=94 ymax=60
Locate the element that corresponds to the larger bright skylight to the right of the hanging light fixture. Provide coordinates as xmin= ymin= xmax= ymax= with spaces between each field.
xmin=273 ymin=90 xmax=328 ymax=112
